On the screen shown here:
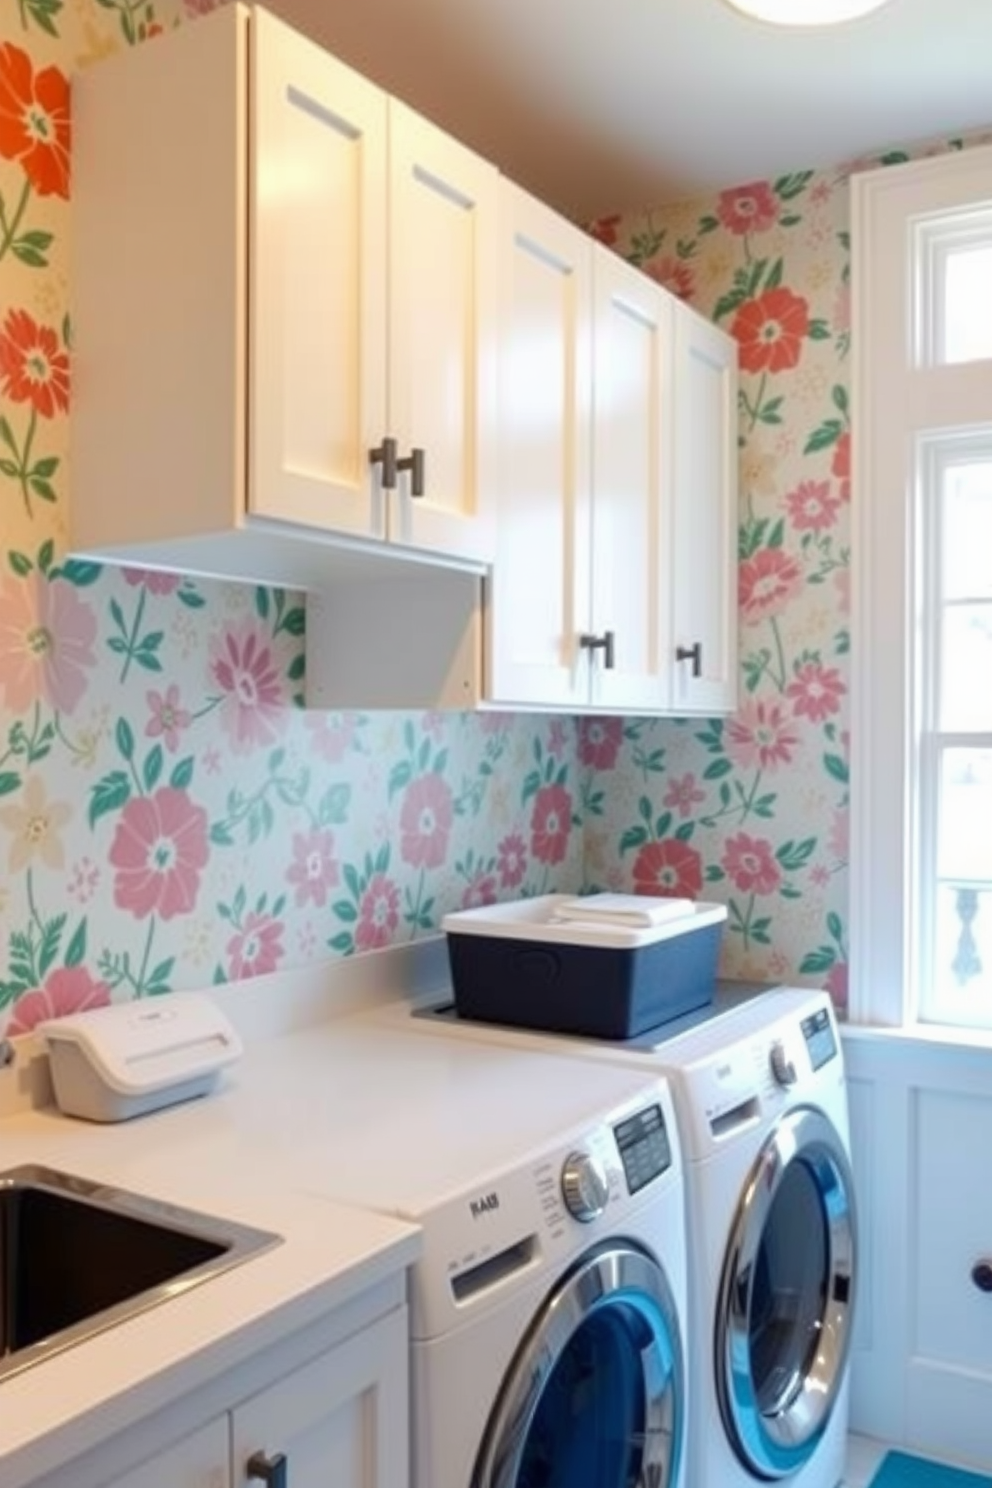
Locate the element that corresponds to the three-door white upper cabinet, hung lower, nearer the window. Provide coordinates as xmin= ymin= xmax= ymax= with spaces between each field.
xmin=485 ymin=180 xmax=736 ymax=713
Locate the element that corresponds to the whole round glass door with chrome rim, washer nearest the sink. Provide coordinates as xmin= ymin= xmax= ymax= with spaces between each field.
xmin=471 ymin=1240 xmax=684 ymax=1488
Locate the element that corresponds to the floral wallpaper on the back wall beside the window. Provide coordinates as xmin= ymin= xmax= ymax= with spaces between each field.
xmin=580 ymin=134 xmax=992 ymax=1007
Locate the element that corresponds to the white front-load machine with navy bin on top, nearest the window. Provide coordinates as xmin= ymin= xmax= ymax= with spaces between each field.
xmin=371 ymin=988 xmax=857 ymax=1488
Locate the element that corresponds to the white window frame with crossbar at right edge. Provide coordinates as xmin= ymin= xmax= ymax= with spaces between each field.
xmin=849 ymin=147 xmax=992 ymax=1027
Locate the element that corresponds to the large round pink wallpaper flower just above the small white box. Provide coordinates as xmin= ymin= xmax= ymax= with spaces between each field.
xmin=110 ymin=786 xmax=210 ymax=920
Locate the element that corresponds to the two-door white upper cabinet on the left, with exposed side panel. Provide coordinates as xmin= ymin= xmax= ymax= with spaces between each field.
xmin=71 ymin=4 xmax=498 ymax=585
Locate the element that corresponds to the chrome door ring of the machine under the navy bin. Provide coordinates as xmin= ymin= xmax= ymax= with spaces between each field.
xmin=714 ymin=1106 xmax=857 ymax=1478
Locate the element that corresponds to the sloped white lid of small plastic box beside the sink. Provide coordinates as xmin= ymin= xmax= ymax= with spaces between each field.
xmin=37 ymin=992 xmax=242 ymax=1095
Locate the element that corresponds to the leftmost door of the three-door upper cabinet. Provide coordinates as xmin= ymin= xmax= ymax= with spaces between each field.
xmin=486 ymin=180 xmax=592 ymax=707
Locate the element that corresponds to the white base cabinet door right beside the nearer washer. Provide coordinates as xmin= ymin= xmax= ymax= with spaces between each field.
xmin=233 ymin=1308 xmax=410 ymax=1488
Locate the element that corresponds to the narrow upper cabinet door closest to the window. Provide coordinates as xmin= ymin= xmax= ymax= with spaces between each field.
xmin=671 ymin=301 xmax=738 ymax=713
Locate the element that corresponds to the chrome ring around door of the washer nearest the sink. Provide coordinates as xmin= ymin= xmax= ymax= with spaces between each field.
xmin=471 ymin=1240 xmax=686 ymax=1488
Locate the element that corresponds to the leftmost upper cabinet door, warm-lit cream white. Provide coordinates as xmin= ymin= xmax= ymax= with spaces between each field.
xmin=248 ymin=10 xmax=388 ymax=537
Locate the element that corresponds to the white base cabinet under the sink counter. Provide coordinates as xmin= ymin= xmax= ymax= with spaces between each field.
xmin=31 ymin=1306 xmax=410 ymax=1488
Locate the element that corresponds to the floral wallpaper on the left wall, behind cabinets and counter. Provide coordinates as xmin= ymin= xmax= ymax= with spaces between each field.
xmin=0 ymin=0 xmax=583 ymax=1034
